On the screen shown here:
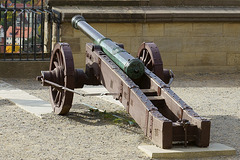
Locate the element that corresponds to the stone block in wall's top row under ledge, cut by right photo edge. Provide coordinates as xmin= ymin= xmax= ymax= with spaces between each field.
xmin=223 ymin=23 xmax=240 ymax=38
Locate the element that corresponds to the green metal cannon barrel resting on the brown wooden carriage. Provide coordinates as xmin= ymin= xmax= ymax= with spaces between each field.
xmin=72 ymin=15 xmax=144 ymax=79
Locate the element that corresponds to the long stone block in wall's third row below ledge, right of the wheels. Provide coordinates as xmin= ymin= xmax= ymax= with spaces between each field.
xmin=177 ymin=52 xmax=227 ymax=66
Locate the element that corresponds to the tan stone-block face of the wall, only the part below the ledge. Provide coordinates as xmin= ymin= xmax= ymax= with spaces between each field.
xmin=60 ymin=22 xmax=240 ymax=71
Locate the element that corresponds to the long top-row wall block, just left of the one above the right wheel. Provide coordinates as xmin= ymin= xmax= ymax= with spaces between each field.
xmin=106 ymin=23 xmax=142 ymax=38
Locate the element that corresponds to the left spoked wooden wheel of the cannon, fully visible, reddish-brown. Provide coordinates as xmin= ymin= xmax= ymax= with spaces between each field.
xmin=49 ymin=43 xmax=74 ymax=115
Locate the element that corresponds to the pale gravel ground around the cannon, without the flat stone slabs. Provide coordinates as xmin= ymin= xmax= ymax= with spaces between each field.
xmin=0 ymin=73 xmax=240 ymax=160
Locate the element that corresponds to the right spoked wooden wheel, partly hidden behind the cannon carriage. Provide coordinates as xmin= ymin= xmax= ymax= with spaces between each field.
xmin=137 ymin=42 xmax=164 ymax=79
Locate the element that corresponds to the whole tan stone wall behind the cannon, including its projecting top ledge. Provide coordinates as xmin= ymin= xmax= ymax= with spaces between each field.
xmin=49 ymin=0 xmax=240 ymax=72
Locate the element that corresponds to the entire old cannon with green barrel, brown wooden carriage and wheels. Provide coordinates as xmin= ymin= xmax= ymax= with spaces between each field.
xmin=37 ymin=15 xmax=211 ymax=149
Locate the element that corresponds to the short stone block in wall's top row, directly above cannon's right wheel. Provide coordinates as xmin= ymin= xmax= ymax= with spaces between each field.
xmin=143 ymin=23 xmax=164 ymax=37
